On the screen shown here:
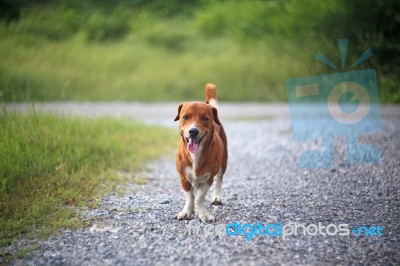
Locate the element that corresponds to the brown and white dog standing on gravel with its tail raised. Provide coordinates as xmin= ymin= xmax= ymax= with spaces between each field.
xmin=175 ymin=84 xmax=228 ymax=221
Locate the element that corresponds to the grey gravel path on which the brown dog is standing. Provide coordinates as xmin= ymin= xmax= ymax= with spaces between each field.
xmin=3 ymin=103 xmax=400 ymax=265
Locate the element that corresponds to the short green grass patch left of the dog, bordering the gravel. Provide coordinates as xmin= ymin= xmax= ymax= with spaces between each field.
xmin=0 ymin=111 xmax=176 ymax=249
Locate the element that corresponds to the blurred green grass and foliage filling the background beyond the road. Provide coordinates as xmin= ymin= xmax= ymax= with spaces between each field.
xmin=0 ymin=0 xmax=400 ymax=102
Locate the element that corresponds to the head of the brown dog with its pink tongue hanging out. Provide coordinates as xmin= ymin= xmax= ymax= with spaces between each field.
xmin=175 ymin=102 xmax=221 ymax=153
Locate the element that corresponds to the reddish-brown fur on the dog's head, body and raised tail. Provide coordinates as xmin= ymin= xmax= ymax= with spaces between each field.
xmin=175 ymin=84 xmax=228 ymax=220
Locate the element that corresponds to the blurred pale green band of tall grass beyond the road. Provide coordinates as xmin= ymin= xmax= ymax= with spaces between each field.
xmin=0 ymin=29 xmax=308 ymax=101
